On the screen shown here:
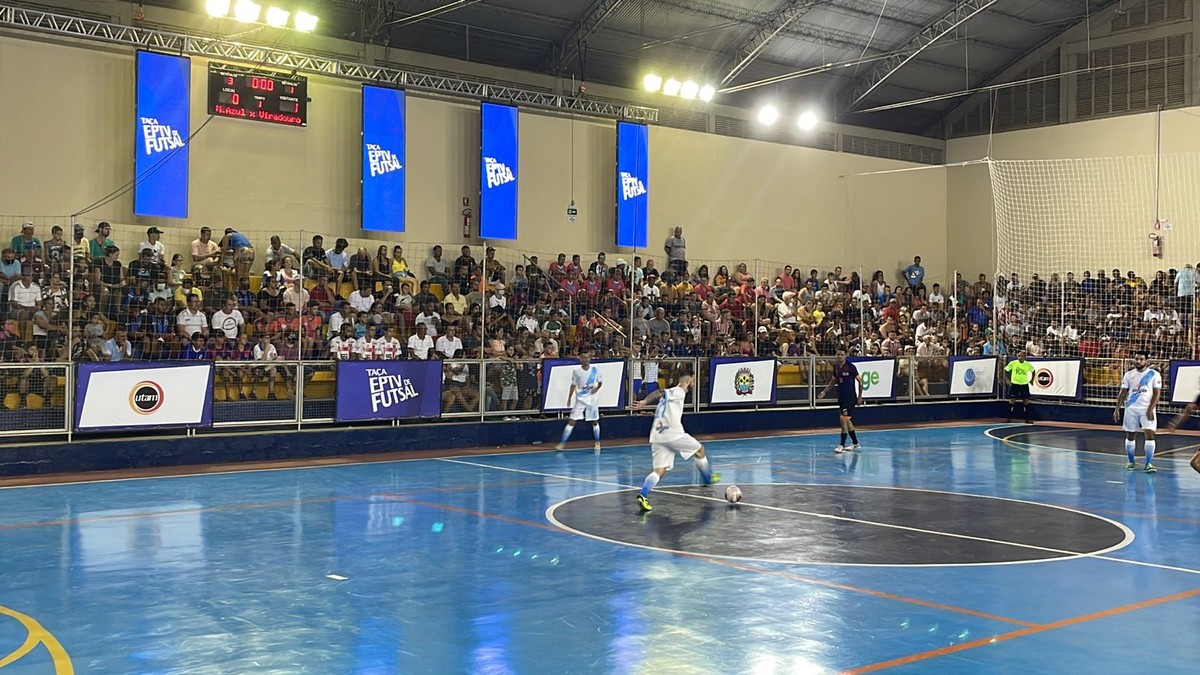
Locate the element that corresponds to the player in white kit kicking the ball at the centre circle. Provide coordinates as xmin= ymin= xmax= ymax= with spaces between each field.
xmin=634 ymin=375 xmax=721 ymax=510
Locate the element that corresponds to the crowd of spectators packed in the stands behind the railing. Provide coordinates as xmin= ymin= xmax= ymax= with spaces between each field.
xmin=0 ymin=222 xmax=1196 ymax=410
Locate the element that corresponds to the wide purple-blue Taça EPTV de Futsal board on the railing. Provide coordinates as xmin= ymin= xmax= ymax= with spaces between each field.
xmin=336 ymin=360 xmax=442 ymax=422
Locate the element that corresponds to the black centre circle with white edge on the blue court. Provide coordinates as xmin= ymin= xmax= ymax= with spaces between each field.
xmin=546 ymin=484 xmax=1133 ymax=567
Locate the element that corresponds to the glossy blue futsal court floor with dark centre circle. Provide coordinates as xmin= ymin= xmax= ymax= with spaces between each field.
xmin=0 ymin=424 xmax=1200 ymax=675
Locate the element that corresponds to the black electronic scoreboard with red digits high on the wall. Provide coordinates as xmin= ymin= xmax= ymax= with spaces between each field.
xmin=209 ymin=64 xmax=308 ymax=126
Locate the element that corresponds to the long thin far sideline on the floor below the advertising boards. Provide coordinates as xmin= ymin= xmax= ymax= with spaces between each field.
xmin=0 ymin=417 xmax=989 ymax=490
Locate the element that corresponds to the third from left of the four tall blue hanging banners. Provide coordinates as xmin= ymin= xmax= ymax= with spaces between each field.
xmin=479 ymin=103 xmax=518 ymax=240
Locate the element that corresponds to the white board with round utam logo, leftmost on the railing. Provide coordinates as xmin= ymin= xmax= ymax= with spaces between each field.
xmin=76 ymin=362 xmax=212 ymax=431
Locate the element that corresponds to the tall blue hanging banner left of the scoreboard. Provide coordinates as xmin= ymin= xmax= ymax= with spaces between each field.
xmin=133 ymin=52 xmax=192 ymax=217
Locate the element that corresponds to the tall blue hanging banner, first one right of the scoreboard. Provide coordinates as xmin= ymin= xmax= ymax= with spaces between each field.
xmin=362 ymin=84 xmax=407 ymax=232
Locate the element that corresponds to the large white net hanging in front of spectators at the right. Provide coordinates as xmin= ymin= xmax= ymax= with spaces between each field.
xmin=984 ymin=154 xmax=1200 ymax=399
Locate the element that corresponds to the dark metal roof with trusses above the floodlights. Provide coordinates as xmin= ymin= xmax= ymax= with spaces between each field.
xmin=58 ymin=0 xmax=1136 ymax=137
